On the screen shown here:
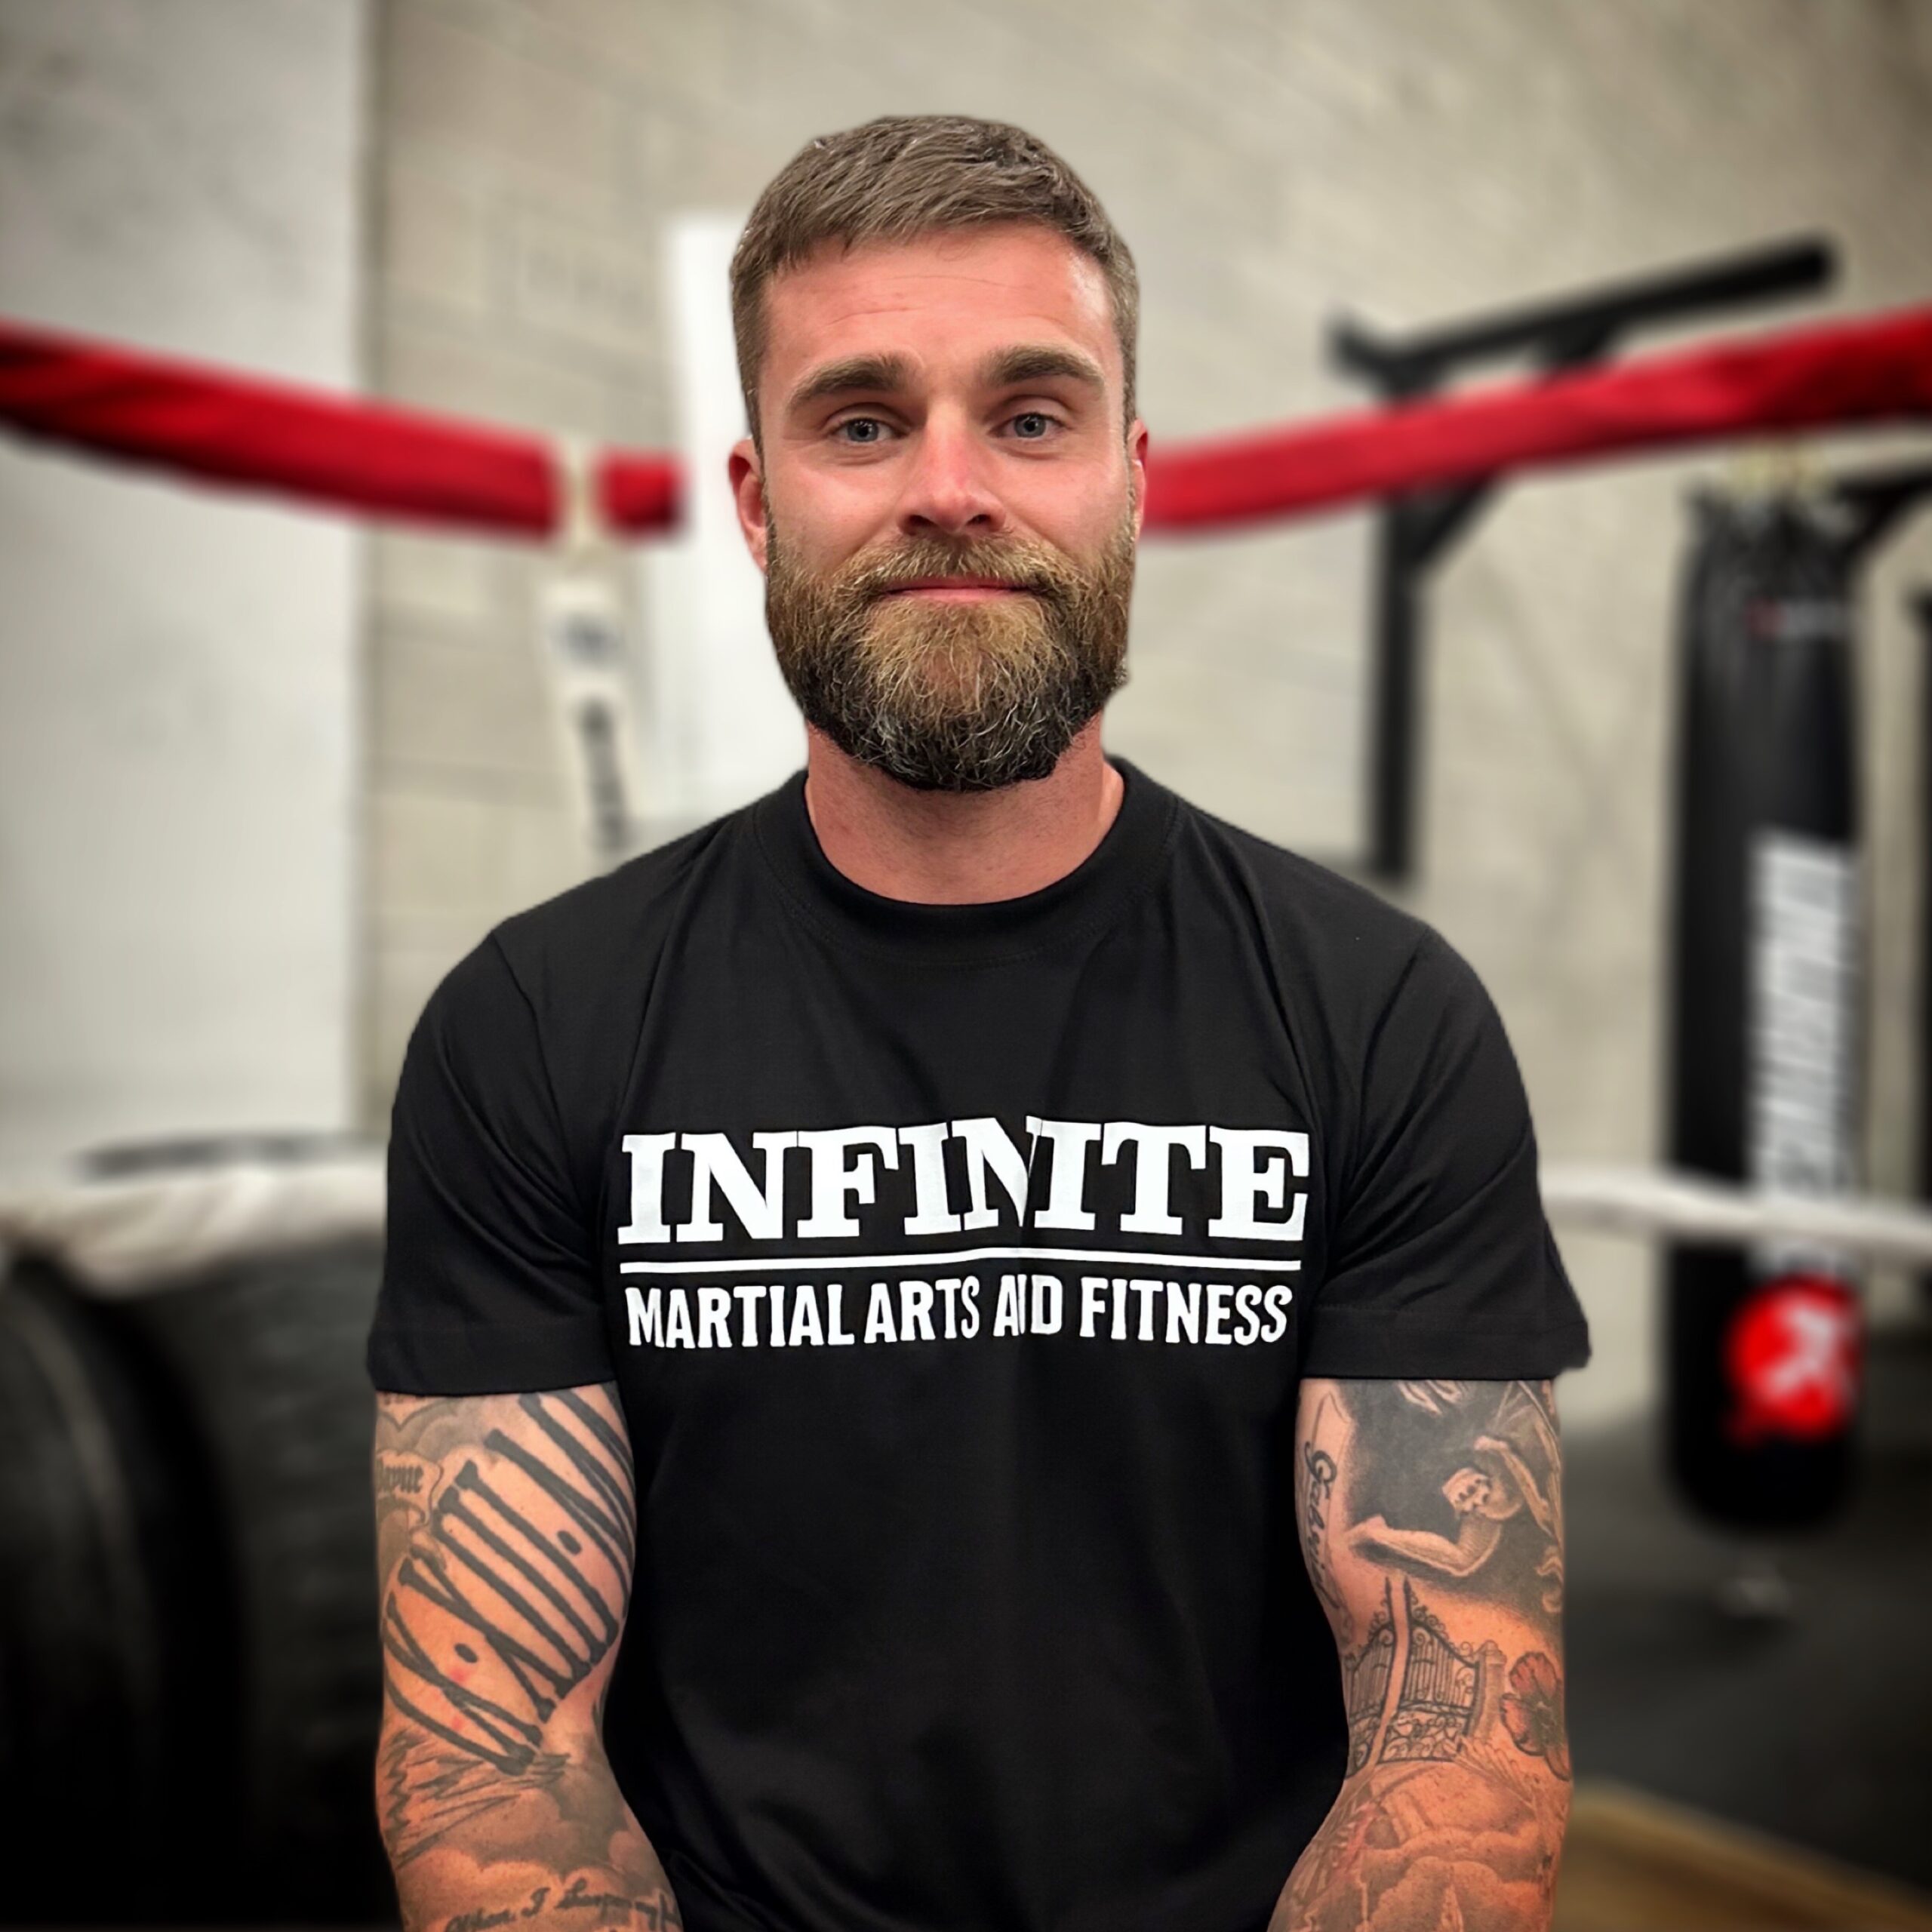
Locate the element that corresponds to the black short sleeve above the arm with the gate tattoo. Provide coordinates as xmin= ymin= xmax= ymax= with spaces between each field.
xmin=1302 ymin=933 xmax=1590 ymax=1381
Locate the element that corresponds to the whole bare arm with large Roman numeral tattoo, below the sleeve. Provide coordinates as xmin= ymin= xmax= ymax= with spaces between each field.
xmin=375 ymin=1386 xmax=680 ymax=1932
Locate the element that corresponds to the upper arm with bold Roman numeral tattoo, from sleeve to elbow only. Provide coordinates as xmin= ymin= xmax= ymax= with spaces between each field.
xmin=375 ymin=1386 xmax=635 ymax=1776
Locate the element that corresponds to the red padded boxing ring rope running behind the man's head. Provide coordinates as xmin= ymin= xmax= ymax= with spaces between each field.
xmin=0 ymin=307 xmax=1932 ymax=537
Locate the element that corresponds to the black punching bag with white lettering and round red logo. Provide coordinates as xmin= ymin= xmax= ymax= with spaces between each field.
xmin=1666 ymin=497 xmax=1860 ymax=1531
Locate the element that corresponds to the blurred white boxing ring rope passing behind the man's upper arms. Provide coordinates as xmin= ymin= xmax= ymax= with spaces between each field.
xmin=0 ymin=1148 xmax=1932 ymax=1297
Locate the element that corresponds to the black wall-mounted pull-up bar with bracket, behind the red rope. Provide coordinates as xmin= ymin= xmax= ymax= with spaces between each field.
xmin=1329 ymin=238 xmax=1835 ymax=884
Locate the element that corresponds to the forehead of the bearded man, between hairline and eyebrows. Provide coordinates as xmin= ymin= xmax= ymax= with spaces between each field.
xmin=759 ymin=224 xmax=1121 ymax=392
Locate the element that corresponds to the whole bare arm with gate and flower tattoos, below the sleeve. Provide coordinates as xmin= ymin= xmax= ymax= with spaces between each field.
xmin=1269 ymin=1381 xmax=1571 ymax=1932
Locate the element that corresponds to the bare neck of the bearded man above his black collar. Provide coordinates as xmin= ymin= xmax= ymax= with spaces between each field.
xmin=806 ymin=718 xmax=1126 ymax=906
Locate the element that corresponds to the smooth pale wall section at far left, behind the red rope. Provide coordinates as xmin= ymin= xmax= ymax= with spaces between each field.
xmin=0 ymin=0 xmax=365 ymax=1167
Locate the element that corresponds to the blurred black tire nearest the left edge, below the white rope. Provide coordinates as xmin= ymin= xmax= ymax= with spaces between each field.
xmin=0 ymin=1263 xmax=235 ymax=1924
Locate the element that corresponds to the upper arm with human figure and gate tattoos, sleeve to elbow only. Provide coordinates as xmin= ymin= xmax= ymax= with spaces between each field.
xmin=1294 ymin=1380 xmax=1569 ymax=1780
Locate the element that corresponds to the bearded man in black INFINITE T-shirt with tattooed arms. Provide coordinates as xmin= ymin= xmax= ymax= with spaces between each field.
xmin=371 ymin=118 xmax=1586 ymax=1932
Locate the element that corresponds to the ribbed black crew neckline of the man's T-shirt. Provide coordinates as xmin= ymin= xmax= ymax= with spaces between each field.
xmin=752 ymin=755 xmax=1179 ymax=964
